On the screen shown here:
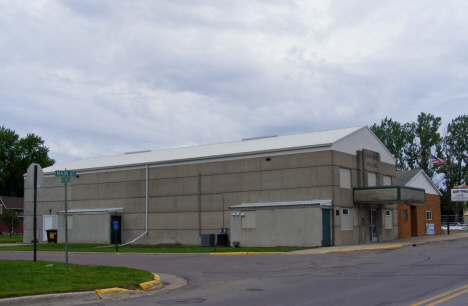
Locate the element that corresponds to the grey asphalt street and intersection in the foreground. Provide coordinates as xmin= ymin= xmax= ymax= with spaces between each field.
xmin=0 ymin=239 xmax=468 ymax=305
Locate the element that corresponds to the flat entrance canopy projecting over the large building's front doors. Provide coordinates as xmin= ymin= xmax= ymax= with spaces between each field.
xmin=353 ymin=186 xmax=426 ymax=203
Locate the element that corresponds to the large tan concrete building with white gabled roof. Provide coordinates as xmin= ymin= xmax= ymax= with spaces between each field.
xmin=24 ymin=126 xmax=416 ymax=246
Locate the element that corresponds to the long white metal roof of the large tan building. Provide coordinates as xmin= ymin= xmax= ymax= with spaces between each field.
xmin=44 ymin=126 xmax=392 ymax=174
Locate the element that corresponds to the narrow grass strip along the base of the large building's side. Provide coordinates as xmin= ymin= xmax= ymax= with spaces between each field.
xmin=0 ymin=243 xmax=310 ymax=253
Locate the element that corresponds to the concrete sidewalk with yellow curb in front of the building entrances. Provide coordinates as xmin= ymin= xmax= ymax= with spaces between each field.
xmin=288 ymin=231 xmax=468 ymax=255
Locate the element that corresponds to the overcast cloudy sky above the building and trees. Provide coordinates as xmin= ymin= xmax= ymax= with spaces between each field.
xmin=0 ymin=0 xmax=468 ymax=162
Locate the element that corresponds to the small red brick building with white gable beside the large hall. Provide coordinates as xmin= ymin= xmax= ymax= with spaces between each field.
xmin=396 ymin=169 xmax=442 ymax=238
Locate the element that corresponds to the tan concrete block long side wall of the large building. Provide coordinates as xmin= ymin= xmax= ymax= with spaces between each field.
xmin=24 ymin=151 xmax=335 ymax=244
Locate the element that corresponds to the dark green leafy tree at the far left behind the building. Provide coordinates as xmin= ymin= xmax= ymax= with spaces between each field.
xmin=0 ymin=126 xmax=55 ymax=197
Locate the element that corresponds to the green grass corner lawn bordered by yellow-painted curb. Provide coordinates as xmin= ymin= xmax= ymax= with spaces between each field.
xmin=0 ymin=260 xmax=154 ymax=298
